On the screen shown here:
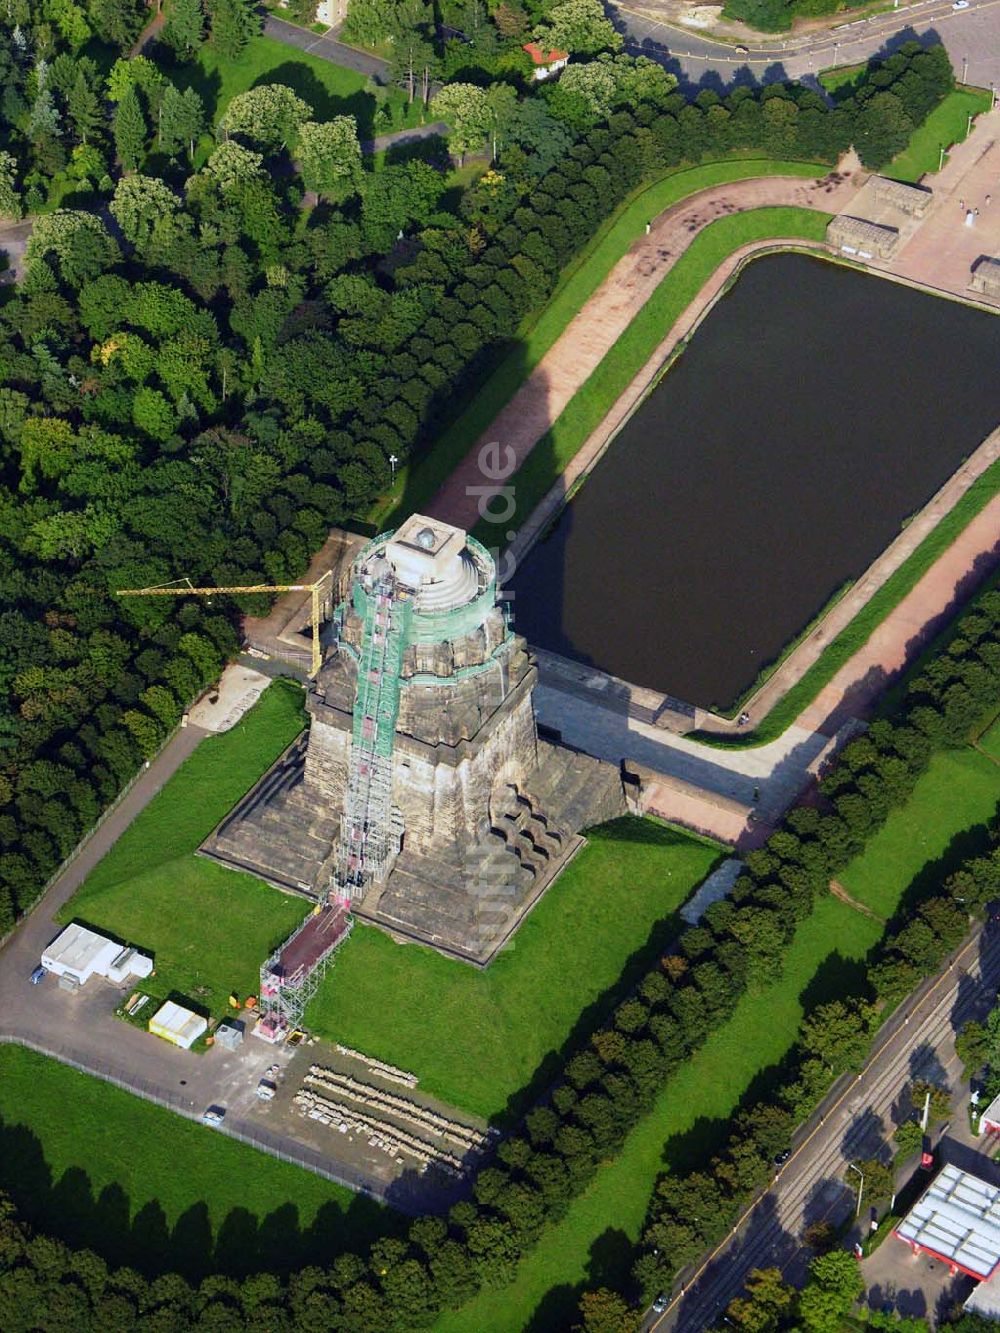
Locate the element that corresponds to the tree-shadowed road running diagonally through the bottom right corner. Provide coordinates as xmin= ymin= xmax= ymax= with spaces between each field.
xmin=645 ymin=930 xmax=1000 ymax=1333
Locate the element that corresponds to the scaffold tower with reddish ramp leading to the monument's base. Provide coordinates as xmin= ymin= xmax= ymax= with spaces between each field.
xmin=253 ymin=904 xmax=353 ymax=1041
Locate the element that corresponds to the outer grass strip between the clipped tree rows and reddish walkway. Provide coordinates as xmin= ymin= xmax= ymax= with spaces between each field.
xmin=369 ymin=157 xmax=829 ymax=529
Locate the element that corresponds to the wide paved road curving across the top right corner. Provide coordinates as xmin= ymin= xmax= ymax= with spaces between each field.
xmin=615 ymin=0 xmax=1000 ymax=88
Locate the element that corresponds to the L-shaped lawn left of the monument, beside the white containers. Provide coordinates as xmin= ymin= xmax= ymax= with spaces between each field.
xmin=59 ymin=680 xmax=305 ymax=1010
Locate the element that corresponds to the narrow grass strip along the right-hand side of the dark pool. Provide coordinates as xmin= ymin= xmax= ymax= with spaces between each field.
xmin=696 ymin=461 xmax=1000 ymax=749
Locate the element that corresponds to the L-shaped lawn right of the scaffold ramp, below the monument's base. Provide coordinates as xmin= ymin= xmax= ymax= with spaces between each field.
xmin=307 ymin=818 xmax=720 ymax=1118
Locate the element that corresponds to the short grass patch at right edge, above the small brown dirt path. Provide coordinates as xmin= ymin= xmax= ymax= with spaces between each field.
xmin=839 ymin=726 xmax=1000 ymax=917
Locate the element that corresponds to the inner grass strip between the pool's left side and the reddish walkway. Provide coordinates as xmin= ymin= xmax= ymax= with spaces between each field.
xmin=487 ymin=208 xmax=829 ymax=536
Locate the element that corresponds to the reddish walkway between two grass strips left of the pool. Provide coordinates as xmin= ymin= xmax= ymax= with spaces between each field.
xmin=428 ymin=171 xmax=857 ymax=528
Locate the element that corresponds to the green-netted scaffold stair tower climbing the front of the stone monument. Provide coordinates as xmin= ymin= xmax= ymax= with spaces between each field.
xmin=336 ymin=571 xmax=413 ymax=898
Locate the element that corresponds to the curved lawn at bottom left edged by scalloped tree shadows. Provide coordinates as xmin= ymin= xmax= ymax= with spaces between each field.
xmin=0 ymin=1045 xmax=405 ymax=1281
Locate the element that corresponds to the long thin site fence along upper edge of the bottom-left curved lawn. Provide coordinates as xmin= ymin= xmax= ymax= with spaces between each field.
xmin=0 ymin=1033 xmax=427 ymax=1217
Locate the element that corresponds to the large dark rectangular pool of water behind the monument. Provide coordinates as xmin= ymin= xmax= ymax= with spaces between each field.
xmin=513 ymin=255 xmax=1000 ymax=706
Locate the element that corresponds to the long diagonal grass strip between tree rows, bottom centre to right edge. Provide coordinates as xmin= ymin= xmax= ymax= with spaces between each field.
xmin=436 ymin=734 xmax=1000 ymax=1333
